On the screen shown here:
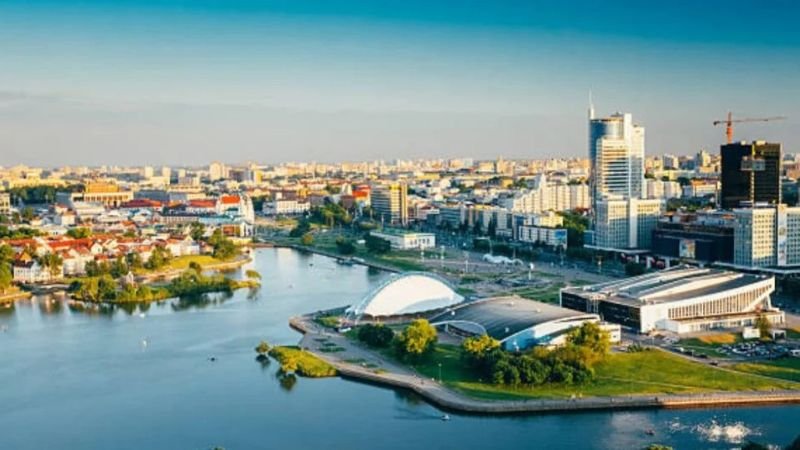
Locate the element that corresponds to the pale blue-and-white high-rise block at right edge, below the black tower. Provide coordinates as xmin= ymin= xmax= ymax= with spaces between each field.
xmin=733 ymin=205 xmax=800 ymax=267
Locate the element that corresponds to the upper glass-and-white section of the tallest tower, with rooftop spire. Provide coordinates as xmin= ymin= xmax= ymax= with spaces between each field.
xmin=589 ymin=108 xmax=644 ymax=201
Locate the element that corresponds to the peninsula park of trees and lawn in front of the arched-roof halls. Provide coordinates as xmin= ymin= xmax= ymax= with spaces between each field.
xmin=348 ymin=319 xmax=800 ymax=400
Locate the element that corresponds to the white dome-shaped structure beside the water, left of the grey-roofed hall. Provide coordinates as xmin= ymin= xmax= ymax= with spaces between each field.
xmin=347 ymin=272 xmax=464 ymax=318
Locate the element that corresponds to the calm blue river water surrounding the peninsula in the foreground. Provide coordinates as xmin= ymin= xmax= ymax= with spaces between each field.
xmin=0 ymin=249 xmax=800 ymax=450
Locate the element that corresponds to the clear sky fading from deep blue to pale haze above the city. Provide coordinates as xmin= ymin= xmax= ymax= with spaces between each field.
xmin=0 ymin=0 xmax=800 ymax=166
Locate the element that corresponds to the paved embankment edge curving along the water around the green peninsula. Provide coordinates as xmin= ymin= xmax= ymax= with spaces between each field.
xmin=289 ymin=316 xmax=800 ymax=415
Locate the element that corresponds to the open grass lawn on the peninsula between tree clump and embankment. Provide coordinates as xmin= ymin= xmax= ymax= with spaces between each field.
xmin=416 ymin=345 xmax=800 ymax=399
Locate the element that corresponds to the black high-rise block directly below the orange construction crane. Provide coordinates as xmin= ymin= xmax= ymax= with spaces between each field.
xmin=720 ymin=141 xmax=781 ymax=209
